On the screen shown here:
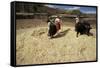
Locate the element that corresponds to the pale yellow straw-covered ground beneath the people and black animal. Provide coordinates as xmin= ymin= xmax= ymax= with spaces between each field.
xmin=16 ymin=20 xmax=96 ymax=65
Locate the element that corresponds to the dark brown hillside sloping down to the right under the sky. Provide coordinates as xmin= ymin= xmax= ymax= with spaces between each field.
xmin=16 ymin=3 xmax=64 ymax=14
